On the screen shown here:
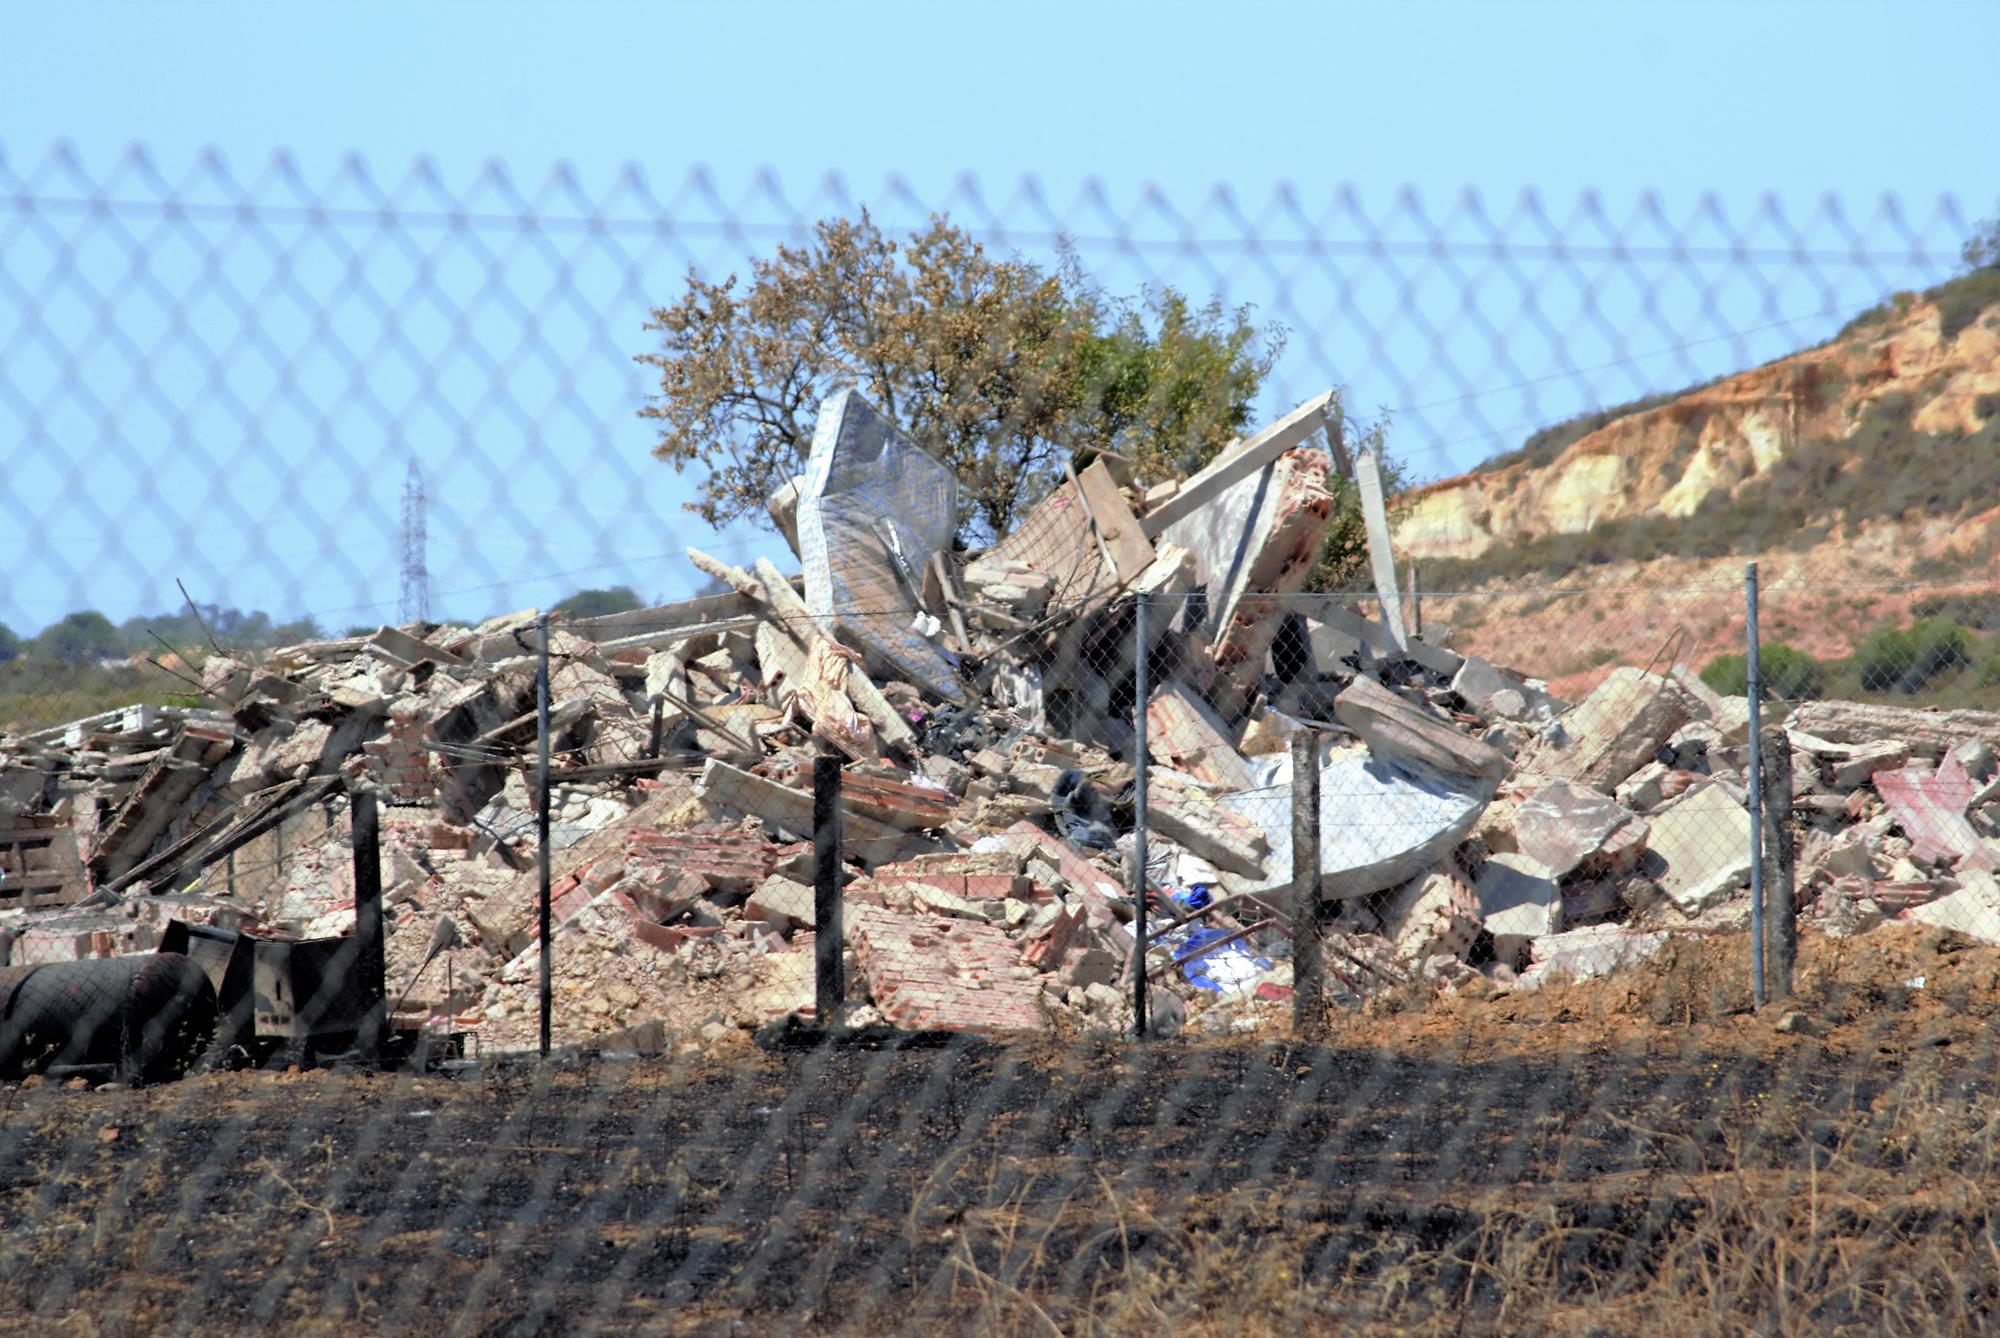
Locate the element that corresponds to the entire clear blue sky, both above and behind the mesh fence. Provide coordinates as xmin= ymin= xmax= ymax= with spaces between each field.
xmin=0 ymin=2 xmax=2000 ymax=628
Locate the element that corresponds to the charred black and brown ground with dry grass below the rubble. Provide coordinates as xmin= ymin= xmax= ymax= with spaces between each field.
xmin=0 ymin=930 xmax=2000 ymax=1334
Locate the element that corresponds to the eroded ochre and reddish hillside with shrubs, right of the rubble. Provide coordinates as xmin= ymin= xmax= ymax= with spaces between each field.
xmin=1396 ymin=270 xmax=2000 ymax=686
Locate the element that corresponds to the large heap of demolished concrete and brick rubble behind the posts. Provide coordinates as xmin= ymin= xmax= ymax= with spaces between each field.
xmin=0 ymin=392 xmax=2000 ymax=1050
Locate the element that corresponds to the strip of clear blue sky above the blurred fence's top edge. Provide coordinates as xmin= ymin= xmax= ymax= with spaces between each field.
xmin=11 ymin=0 xmax=2000 ymax=207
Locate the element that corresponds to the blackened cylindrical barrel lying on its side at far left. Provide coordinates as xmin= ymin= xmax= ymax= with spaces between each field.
xmin=0 ymin=952 xmax=216 ymax=1082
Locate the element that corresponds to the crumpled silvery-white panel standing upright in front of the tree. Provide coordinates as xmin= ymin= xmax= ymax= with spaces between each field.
xmin=798 ymin=388 xmax=964 ymax=702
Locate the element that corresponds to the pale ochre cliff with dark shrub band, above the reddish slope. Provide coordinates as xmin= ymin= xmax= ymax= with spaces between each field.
xmin=1396 ymin=270 xmax=2000 ymax=574
